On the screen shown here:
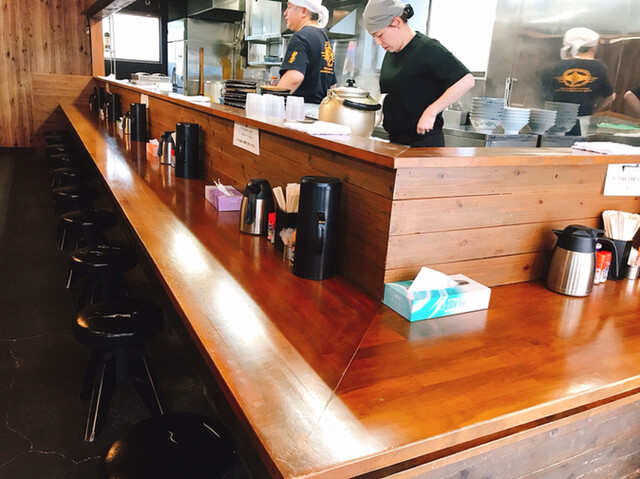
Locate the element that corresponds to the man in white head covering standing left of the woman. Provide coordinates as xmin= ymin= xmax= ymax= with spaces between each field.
xmin=278 ymin=0 xmax=337 ymax=105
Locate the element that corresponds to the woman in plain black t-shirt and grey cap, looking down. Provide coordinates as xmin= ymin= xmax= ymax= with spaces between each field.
xmin=363 ymin=0 xmax=475 ymax=146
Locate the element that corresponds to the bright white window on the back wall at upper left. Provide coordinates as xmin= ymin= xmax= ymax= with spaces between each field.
xmin=102 ymin=13 xmax=160 ymax=63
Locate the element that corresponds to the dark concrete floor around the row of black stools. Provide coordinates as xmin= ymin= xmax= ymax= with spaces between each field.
xmin=0 ymin=148 xmax=251 ymax=479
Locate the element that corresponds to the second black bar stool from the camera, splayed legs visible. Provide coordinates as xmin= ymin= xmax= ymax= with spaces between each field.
xmin=73 ymin=300 xmax=163 ymax=442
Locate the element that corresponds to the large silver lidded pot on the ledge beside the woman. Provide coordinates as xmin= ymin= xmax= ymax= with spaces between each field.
xmin=318 ymin=79 xmax=382 ymax=137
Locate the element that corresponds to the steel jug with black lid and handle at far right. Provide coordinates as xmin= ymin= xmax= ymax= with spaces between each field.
xmin=547 ymin=225 xmax=616 ymax=296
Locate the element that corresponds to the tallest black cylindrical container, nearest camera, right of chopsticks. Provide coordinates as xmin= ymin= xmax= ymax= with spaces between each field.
xmin=293 ymin=176 xmax=342 ymax=280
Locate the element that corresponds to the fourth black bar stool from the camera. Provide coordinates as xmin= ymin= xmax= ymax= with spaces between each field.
xmin=58 ymin=210 xmax=117 ymax=250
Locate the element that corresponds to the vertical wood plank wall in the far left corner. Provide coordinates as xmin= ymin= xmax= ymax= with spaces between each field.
xmin=0 ymin=0 xmax=91 ymax=147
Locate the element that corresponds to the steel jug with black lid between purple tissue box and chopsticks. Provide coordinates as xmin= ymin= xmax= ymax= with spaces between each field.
xmin=240 ymin=178 xmax=273 ymax=236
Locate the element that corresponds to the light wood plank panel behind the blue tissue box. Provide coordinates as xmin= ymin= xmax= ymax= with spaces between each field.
xmin=384 ymin=164 xmax=640 ymax=286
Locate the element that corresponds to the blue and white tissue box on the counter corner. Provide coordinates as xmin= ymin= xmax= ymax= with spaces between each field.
xmin=382 ymin=274 xmax=491 ymax=321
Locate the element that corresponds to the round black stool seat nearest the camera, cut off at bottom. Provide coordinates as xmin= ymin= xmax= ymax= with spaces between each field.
xmin=100 ymin=413 xmax=237 ymax=479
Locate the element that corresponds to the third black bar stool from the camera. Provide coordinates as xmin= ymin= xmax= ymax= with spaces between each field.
xmin=66 ymin=243 xmax=137 ymax=311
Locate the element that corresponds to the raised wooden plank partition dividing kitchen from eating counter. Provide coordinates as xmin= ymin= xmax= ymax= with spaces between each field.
xmin=95 ymin=82 xmax=640 ymax=299
